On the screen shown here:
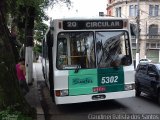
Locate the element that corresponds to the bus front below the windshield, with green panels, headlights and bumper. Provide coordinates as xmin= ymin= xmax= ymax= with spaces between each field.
xmin=55 ymin=67 xmax=135 ymax=104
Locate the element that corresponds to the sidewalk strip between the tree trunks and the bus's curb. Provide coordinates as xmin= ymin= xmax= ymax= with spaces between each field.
xmin=25 ymin=63 xmax=45 ymax=120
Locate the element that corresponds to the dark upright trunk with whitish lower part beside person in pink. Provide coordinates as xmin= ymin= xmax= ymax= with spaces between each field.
xmin=18 ymin=5 xmax=35 ymax=84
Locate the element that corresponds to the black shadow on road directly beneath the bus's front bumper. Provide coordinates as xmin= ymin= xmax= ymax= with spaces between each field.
xmin=57 ymin=100 xmax=127 ymax=113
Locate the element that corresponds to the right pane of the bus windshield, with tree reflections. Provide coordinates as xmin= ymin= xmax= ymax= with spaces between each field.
xmin=96 ymin=31 xmax=131 ymax=68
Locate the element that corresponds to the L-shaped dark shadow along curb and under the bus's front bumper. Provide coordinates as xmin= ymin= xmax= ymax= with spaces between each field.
xmin=38 ymin=81 xmax=127 ymax=114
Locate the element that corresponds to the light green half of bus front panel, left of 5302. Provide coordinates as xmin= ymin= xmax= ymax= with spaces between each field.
xmin=68 ymin=69 xmax=98 ymax=95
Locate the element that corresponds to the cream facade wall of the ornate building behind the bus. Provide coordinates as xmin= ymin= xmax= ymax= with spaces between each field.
xmin=106 ymin=0 xmax=160 ymax=62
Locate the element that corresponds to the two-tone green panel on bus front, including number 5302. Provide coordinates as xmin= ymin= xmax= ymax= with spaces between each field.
xmin=68 ymin=67 xmax=124 ymax=96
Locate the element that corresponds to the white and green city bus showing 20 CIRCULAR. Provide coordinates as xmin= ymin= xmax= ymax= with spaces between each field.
xmin=42 ymin=17 xmax=135 ymax=104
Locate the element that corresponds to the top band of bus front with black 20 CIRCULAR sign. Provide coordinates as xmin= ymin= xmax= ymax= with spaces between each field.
xmin=50 ymin=16 xmax=129 ymax=30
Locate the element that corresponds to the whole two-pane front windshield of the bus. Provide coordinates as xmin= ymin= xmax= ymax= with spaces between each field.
xmin=57 ymin=31 xmax=132 ymax=70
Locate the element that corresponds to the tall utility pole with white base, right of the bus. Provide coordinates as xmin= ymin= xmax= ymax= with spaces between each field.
xmin=136 ymin=0 xmax=140 ymax=67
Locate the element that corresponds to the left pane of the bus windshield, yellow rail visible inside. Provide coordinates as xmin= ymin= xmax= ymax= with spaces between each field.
xmin=57 ymin=32 xmax=95 ymax=69
